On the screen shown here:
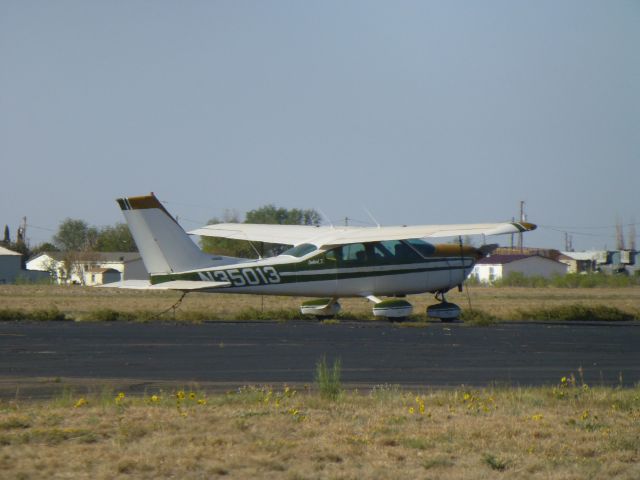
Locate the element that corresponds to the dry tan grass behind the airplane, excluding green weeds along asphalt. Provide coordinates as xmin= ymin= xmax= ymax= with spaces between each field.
xmin=0 ymin=285 xmax=640 ymax=320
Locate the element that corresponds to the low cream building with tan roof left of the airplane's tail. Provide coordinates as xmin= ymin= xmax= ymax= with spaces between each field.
xmin=27 ymin=252 xmax=149 ymax=286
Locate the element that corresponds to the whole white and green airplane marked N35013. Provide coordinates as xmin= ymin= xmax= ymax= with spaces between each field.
xmin=110 ymin=193 xmax=536 ymax=320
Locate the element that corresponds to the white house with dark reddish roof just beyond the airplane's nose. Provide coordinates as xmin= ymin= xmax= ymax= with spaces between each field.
xmin=471 ymin=254 xmax=568 ymax=283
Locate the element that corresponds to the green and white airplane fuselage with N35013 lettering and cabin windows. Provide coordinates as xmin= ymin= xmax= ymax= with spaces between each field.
xmin=151 ymin=241 xmax=478 ymax=297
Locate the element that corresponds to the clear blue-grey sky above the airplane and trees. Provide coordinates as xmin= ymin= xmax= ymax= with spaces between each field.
xmin=0 ymin=0 xmax=640 ymax=250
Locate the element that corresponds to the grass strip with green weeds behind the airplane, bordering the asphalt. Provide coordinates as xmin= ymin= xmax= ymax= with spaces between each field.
xmin=0 ymin=285 xmax=640 ymax=326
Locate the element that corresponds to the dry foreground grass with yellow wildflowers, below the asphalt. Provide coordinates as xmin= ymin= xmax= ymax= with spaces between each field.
xmin=0 ymin=378 xmax=640 ymax=480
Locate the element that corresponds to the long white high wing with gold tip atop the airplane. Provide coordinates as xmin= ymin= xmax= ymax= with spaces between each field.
xmin=189 ymin=222 xmax=536 ymax=247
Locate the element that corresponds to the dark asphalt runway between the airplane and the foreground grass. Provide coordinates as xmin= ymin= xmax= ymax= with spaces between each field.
xmin=0 ymin=321 xmax=640 ymax=398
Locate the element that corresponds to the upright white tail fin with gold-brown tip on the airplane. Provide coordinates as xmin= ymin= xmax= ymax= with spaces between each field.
xmin=117 ymin=193 xmax=221 ymax=275
